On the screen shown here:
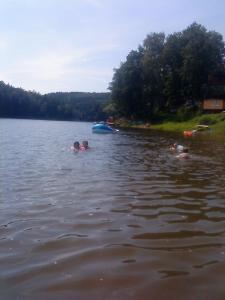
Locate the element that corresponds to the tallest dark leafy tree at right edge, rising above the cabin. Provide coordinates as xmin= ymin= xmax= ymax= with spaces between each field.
xmin=180 ymin=23 xmax=225 ymax=101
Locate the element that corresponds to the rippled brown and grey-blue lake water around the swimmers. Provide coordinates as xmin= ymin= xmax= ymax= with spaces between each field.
xmin=0 ymin=119 xmax=225 ymax=300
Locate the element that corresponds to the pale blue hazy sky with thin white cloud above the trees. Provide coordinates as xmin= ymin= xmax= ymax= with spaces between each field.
xmin=0 ymin=0 xmax=225 ymax=94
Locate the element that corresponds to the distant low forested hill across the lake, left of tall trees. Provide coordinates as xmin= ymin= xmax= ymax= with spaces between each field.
xmin=0 ymin=81 xmax=109 ymax=121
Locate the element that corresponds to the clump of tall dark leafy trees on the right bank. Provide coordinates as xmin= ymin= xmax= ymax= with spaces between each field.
xmin=110 ymin=23 xmax=225 ymax=119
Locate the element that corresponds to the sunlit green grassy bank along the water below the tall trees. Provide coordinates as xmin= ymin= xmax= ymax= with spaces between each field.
xmin=119 ymin=112 xmax=225 ymax=134
